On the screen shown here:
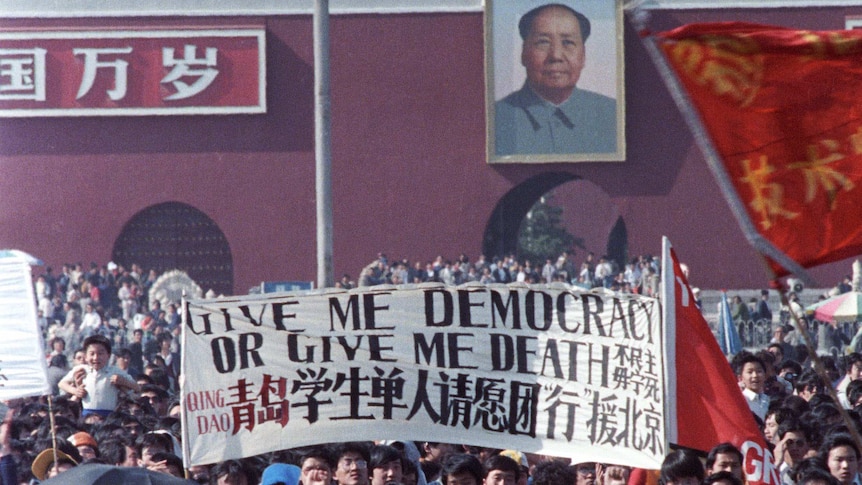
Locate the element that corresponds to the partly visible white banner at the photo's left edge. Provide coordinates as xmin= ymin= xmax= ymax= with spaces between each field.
xmin=0 ymin=251 xmax=51 ymax=401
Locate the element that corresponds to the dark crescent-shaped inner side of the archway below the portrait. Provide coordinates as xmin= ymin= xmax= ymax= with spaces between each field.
xmin=482 ymin=172 xmax=580 ymax=258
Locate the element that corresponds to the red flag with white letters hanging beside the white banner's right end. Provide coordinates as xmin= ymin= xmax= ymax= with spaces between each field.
xmin=663 ymin=238 xmax=781 ymax=485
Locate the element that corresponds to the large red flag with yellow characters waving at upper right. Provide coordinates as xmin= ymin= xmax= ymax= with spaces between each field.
xmin=657 ymin=22 xmax=862 ymax=276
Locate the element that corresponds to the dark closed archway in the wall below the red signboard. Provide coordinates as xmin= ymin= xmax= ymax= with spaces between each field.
xmin=113 ymin=202 xmax=233 ymax=295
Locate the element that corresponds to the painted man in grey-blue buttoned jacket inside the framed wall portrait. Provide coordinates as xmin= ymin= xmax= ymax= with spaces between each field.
xmin=494 ymin=4 xmax=617 ymax=155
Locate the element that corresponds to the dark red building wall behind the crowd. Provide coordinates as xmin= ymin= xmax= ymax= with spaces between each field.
xmin=0 ymin=8 xmax=862 ymax=293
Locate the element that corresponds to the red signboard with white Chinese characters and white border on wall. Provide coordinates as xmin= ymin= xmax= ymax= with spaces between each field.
xmin=0 ymin=28 xmax=266 ymax=117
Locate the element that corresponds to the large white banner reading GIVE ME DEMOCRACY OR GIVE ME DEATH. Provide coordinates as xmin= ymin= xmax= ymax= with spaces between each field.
xmin=182 ymin=284 xmax=667 ymax=468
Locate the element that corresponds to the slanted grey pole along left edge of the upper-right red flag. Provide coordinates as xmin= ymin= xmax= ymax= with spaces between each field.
xmin=625 ymin=2 xmax=813 ymax=285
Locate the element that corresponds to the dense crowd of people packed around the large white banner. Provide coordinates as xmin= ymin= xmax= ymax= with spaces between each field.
xmin=5 ymin=253 xmax=862 ymax=485
